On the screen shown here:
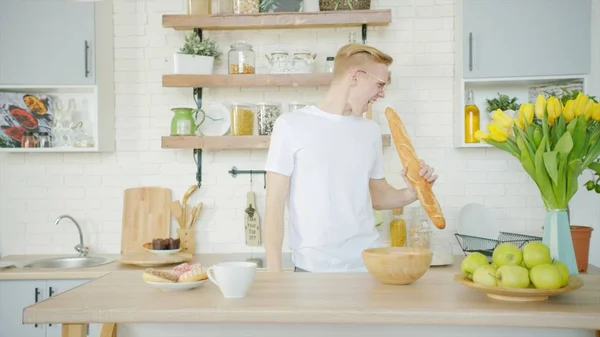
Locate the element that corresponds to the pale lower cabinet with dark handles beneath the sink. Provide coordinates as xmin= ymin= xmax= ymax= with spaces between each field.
xmin=0 ymin=280 xmax=101 ymax=337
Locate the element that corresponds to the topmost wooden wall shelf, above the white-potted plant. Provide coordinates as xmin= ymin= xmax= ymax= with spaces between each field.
xmin=162 ymin=9 xmax=392 ymax=30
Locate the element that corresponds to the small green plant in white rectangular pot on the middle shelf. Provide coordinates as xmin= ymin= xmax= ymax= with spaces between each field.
xmin=173 ymin=33 xmax=223 ymax=75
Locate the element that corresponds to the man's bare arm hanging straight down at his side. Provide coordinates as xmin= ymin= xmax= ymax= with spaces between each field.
xmin=265 ymin=172 xmax=290 ymax=272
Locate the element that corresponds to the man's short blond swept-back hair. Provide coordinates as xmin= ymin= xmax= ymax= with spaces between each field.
xmin=333 ymin=43 xmax=394 ymax=77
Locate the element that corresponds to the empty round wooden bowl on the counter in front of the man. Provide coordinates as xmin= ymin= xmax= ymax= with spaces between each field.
xmin=362 ymin=247 xmax=433 ymax=285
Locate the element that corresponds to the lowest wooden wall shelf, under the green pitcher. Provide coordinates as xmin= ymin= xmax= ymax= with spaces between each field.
xmin=162 ymin=135 xmax=391 ymax=150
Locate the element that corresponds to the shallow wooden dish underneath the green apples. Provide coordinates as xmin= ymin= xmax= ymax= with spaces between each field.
xmin=454 ymin=274 xmax=583 ymax=302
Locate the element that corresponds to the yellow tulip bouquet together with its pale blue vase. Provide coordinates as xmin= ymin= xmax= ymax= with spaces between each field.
xmin=475 ymin=92 xmax=600 ymax=274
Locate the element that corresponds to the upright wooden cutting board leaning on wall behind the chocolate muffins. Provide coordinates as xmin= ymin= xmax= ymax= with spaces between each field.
xmin=121 ymin=187 xmax=172 ymax=255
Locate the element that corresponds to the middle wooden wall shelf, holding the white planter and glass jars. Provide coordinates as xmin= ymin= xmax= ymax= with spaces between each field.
xmin=162 ymin=72 xmax=392 ymax=88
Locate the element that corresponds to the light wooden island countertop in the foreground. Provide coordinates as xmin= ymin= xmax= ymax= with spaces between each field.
xmin=23 ymin=263 xmax=600 ymax=330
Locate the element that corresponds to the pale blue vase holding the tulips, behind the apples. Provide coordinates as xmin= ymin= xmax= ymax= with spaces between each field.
xmin=542 ymin=209 xmax=579 ymax=275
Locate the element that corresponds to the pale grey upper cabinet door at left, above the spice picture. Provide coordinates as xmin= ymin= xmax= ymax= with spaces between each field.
xmin=0 ymin=0 xmax=96 ymax=85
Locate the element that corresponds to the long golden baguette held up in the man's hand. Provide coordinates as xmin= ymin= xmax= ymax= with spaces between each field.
xmin=385 ymin=107 xmax=446 ymax=229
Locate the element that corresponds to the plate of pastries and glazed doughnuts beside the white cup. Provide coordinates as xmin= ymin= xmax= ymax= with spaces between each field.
xmin=142 ymin=262 xmax=208 ymax=291
